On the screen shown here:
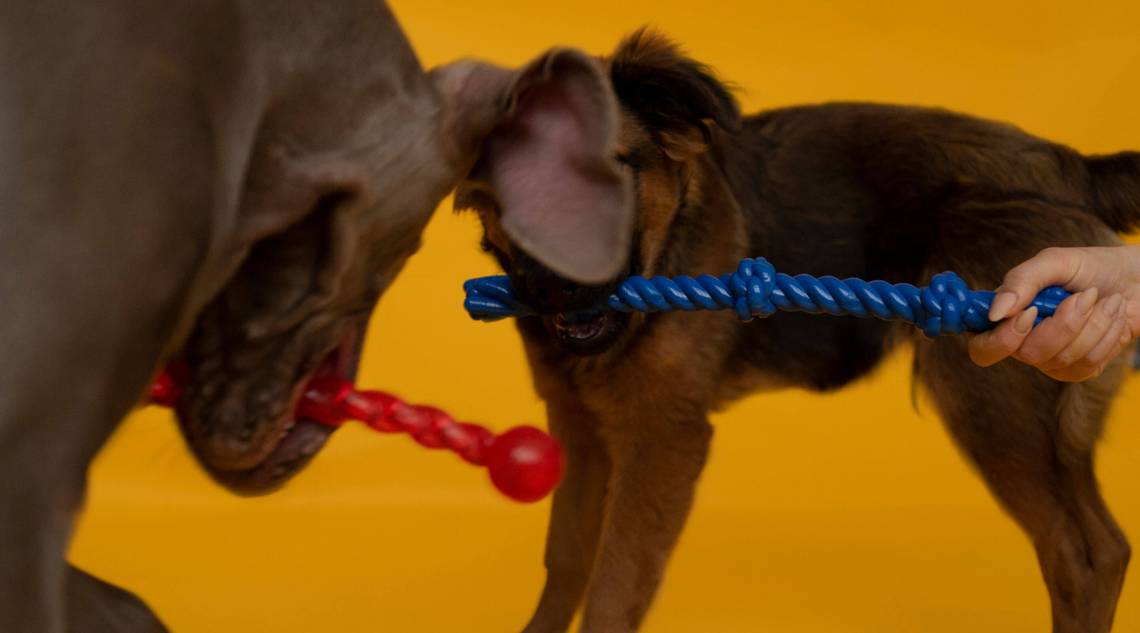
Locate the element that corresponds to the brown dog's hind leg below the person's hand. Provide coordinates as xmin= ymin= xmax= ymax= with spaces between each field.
xmin=918 ymin=339 xmax=1130 ymax=633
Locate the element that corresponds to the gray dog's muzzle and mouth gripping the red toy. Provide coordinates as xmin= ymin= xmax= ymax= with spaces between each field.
xmin=177 ymin=327 xmax=360 ymax=495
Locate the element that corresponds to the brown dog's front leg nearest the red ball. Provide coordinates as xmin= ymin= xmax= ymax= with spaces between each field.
xmin=524 ymin=401 xmax=610 ymax=633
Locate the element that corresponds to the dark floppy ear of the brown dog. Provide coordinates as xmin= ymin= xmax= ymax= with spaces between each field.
xmin=610 ymin=29 xmax=741 ymax=161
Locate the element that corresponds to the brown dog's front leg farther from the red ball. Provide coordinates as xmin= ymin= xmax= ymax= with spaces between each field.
xmin=583 ymin=407 xmax=713 ymax=633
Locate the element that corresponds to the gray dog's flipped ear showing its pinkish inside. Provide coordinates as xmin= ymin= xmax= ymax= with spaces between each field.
xmin=432 ymin=49 xmax=633 ymax=283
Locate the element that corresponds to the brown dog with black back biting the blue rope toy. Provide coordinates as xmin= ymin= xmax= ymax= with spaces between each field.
xmin=457 ymin=32 xmax=1140 ymax=633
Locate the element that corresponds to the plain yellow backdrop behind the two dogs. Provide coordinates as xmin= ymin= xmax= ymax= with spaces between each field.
xmin=72 ymin=0 xmax=1140 ymax=633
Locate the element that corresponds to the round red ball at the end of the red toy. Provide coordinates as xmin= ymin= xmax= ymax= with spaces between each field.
xmin=487 ymin=427 xmax=562 ymax=503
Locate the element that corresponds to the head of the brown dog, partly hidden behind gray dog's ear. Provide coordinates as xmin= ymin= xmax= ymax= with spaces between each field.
xmin=456 ymin=31 xmax=740 ymax=356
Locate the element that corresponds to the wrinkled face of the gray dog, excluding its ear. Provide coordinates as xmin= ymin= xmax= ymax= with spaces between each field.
xmin=179 ymin=181 xmax=435 ymax=494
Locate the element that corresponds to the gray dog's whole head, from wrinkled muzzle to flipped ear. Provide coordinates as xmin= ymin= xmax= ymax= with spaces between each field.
xmin=177 ymin=49 xmax=630 ymax=494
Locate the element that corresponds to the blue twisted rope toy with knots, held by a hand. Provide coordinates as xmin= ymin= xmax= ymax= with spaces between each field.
xmin=463 ymin=258 xmax=1069 ymax=338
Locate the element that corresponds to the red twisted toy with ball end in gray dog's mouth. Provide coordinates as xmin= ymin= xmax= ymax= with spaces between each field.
xmin=150 ymin=370 xmax=562 ymax=503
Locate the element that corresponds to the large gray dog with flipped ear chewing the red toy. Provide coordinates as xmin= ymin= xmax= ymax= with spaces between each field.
xmin=0 ymin=0 xmax=630 ymax=633
